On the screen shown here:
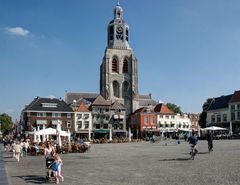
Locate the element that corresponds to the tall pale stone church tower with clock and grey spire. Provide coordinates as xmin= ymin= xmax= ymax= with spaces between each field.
xmin=100 ymin=3 xmax=138 ymax=115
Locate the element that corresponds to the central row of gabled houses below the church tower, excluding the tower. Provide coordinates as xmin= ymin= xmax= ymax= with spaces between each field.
xmin=17 ymin=93 xmax=198 ymax=139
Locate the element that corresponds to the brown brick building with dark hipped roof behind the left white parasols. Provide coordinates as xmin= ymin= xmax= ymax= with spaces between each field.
xmin=20 ymin=97 xmax=74 ymax=139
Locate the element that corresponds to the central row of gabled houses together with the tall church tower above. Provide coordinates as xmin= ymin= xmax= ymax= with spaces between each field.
xmin=15 ymin=3 xmax=202 ymax=138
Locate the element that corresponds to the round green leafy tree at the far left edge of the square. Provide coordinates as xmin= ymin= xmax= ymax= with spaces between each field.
xmin=0 ymin=113 xmax=13 ymax=137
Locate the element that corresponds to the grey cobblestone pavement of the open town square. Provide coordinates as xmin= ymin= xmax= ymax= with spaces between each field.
xmin=3 ymin=140 xmax=240 ymax=185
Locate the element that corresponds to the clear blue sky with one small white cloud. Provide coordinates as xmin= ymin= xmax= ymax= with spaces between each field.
xmin=0 ymin=0 xmax=240 ymax=120
